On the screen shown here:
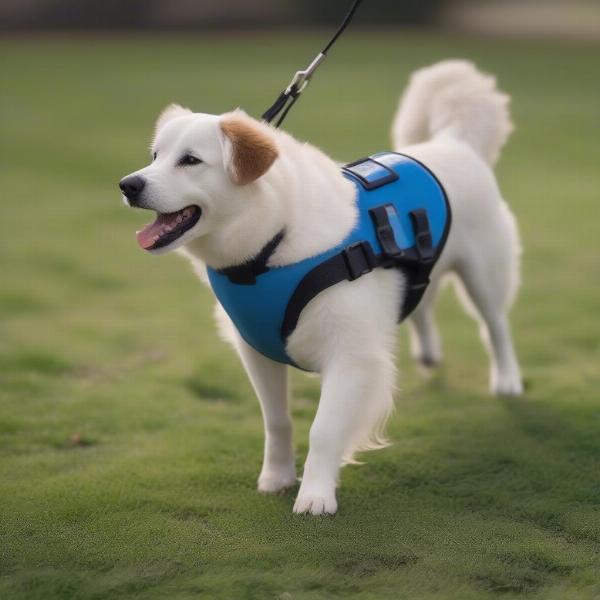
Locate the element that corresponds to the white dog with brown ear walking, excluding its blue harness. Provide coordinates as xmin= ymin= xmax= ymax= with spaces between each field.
xmin=121 ymin=61 xmax=522 ymax=515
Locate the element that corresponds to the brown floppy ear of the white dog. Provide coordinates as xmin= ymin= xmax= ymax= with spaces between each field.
xmin=219 ymin=109 xmax=278 ymax=185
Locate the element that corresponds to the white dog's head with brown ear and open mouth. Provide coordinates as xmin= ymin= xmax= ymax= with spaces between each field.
xmin=119 ymin=105 xmax=278 ymax=253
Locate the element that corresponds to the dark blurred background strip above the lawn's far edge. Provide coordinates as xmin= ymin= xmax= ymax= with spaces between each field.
xmin=0 ymin=0 xmax=600 ymax=39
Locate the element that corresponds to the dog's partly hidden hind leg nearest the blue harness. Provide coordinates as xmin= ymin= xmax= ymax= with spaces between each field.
xmin=408 ymin=281 xmax=442 ymax=368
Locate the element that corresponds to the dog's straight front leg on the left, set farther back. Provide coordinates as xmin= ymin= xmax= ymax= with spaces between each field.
xmin=236 ymin=334 xmax=296 ymax=493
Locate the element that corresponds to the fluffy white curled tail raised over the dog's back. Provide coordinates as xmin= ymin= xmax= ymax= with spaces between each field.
xmin=392 ymin=60 xmax=513 ymax=165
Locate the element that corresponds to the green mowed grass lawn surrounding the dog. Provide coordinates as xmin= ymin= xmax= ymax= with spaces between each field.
xmin=0 ymin=32 xmax=600 ymax=600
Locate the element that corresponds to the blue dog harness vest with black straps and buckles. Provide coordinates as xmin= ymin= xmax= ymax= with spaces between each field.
xmin=208 ymin=152 xmax=451 ymax=365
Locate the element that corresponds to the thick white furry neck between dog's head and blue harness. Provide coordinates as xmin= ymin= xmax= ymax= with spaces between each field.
xmin=180 ymin=131 xmax=357 ymax=269
